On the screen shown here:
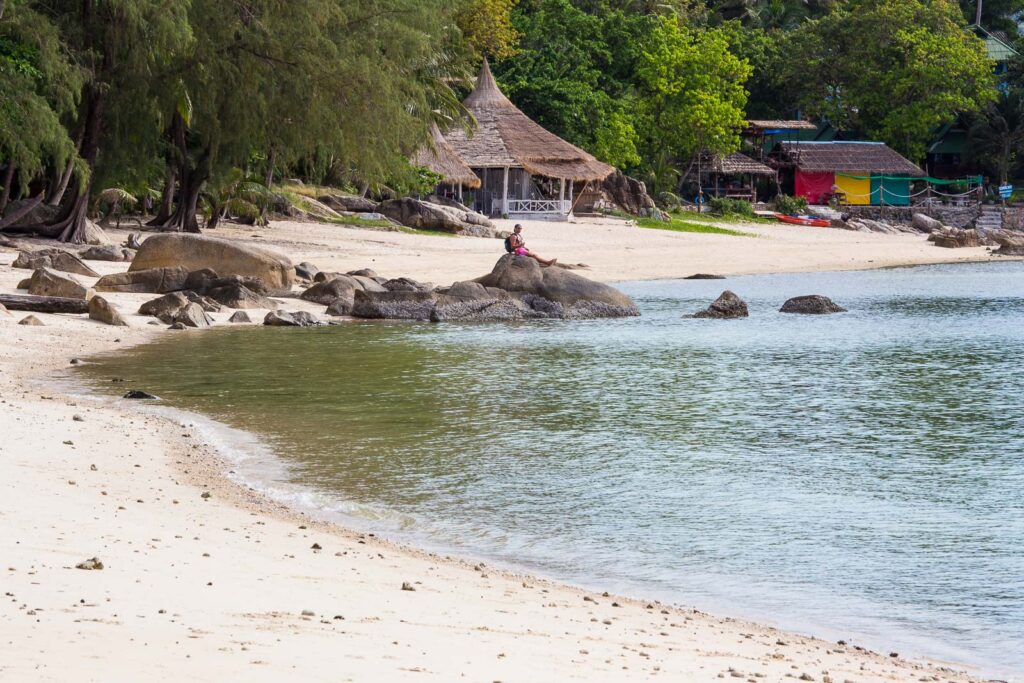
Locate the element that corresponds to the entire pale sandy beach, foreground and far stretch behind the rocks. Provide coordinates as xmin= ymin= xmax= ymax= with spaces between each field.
xmin=0 ymin=219 xmax=993 ymax=683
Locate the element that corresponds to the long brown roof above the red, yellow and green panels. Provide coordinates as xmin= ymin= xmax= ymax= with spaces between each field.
xmin=778 ymin=141 xmax=925 ymax=177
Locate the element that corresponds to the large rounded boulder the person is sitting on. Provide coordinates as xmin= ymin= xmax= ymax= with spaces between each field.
xmin=476 ymin=254 xmax=640 ymax=317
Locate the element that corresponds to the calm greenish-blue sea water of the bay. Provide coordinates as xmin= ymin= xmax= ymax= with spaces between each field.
xmin=82 ymin=263 xmax=1024 ymax=678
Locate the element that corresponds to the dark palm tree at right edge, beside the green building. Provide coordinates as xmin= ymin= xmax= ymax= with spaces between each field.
xmin=968 ymin=89 xmax=1024 ymax=183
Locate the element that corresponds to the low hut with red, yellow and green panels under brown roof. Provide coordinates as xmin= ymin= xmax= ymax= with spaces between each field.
xmin=773 ymin=141 xmax=925 ymax=206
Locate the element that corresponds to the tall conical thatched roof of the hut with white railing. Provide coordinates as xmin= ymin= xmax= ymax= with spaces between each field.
xmin=445 ymin=59 xmax=615 ymax=180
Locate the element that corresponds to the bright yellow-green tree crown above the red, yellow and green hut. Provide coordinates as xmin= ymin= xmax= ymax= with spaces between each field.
xmin=785 ymin=0 xmax=995 ymax=160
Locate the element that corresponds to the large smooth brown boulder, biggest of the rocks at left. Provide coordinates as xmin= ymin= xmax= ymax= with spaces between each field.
xmin=129 ymin=233 xmax=295 ymax=292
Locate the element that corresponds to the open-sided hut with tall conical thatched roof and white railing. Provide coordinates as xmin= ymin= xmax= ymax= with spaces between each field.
xmin=444 ymin=59 xmax=615 ymax=218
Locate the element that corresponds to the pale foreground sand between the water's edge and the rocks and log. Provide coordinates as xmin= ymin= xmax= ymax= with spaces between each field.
xmin=0 ymin=220 xmax=1001 ymax=682
